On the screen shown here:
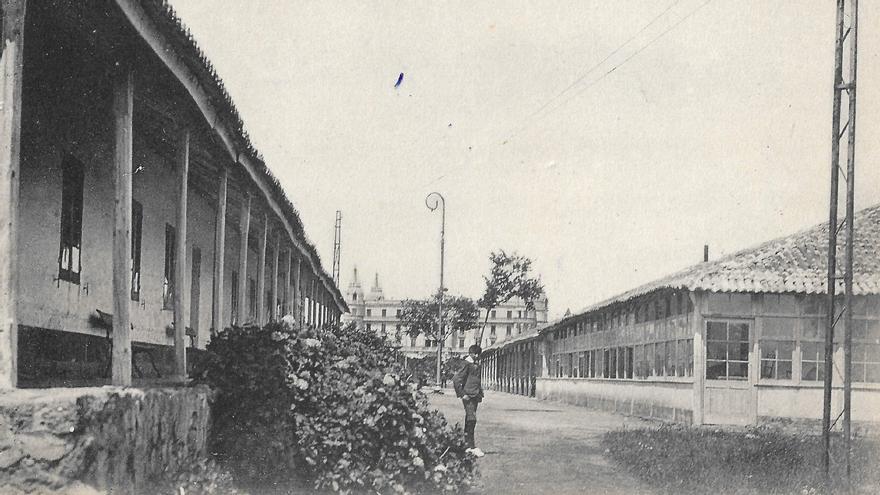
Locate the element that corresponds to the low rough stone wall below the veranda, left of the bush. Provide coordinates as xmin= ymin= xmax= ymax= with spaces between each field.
xmin=0 ymin=387 xmax=209 ymax=493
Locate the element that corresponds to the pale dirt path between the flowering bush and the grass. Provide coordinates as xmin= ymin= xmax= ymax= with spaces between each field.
xmin=428 ymin=390 xmax=651 ymax=495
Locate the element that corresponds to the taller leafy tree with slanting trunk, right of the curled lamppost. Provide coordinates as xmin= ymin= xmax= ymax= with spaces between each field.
xmin=477 ymin=249 xmax=544 ymax=342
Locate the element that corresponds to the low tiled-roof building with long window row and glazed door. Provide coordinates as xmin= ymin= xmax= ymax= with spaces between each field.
xmin=483 ymin=206 xmax=880 ymax=424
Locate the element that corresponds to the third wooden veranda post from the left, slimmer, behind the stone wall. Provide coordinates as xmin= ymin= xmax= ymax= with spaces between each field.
xmin=174 ymin=130 xmax=189 ymax=380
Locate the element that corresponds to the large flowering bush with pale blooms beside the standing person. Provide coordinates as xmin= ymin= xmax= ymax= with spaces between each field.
xmin=200 ymin=324 xmax=474 ymax=493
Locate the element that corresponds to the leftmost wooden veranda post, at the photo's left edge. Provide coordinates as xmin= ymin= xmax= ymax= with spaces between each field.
xmin=0 ymin=0 xmax=26 ymax=389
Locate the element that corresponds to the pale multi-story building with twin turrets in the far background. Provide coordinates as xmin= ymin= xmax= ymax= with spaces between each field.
xmin=343 ymin=268 xmax=547 ymax=357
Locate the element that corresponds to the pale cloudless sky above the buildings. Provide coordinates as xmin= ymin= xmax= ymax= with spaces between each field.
xmin=172 ymin=0 xmax=880 ymax=319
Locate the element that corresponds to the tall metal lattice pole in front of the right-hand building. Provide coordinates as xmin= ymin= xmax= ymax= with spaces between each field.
xmin=822 ymin=0 xmax=858 ymax=488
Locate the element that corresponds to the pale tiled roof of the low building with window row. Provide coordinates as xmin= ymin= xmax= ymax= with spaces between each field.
xmin=576 ymin=205 xmax=880 ymax=315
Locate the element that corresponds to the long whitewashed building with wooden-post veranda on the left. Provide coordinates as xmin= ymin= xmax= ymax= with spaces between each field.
xmin=0 ymin=0 xmax=348 ymax=389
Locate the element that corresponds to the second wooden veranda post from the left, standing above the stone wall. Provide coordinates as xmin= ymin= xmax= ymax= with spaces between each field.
xmin=112 ymin=63 xmax=134 ymax=386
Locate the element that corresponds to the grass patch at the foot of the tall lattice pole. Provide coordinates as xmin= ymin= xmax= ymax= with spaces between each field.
xmin=602 ymin=425 xmax=880 ymax=495
